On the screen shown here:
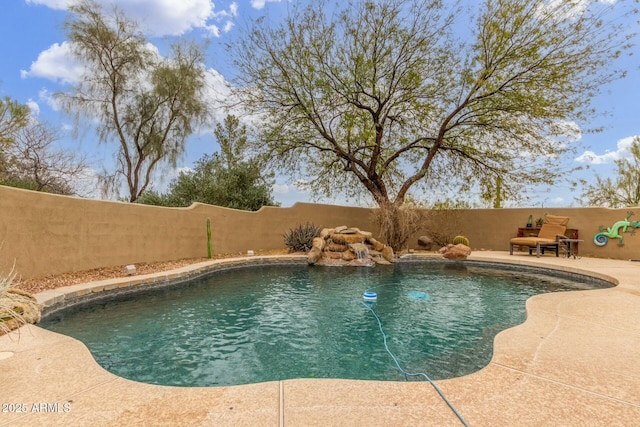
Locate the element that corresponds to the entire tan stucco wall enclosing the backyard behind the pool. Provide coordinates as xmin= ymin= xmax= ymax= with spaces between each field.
xmin=0 ymin=186 xmax=640 ymax=279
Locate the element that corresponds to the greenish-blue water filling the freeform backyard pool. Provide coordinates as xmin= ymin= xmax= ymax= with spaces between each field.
xmin=41 ymin=263 xmax=604 ymax=386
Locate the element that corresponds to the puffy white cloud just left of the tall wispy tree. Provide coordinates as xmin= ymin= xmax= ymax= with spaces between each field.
xmin=20 ymin=42 xmax=84 ymax=83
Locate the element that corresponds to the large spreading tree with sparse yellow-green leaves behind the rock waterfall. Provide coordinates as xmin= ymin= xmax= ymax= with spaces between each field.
xmin=231 ymin=0 xmax=626 ymax=248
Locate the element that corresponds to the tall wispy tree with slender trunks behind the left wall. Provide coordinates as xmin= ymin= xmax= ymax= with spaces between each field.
xmin=58 ymin=0 xmax=207 ymax=202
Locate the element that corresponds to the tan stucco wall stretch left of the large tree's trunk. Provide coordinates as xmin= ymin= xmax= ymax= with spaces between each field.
xmin=0 ymin=186 xmax=374 ymax=279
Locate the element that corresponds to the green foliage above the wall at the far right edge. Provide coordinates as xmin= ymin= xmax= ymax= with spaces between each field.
xmin=582 ymin=137 xmax=640 ymax=208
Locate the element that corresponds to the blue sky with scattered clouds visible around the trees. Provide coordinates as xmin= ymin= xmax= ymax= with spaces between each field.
xmin=0 ymin=0 xmax=640 ymax=207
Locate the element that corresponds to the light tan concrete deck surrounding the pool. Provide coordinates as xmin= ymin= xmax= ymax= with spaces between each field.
xmin=0 ymin=251 xmax=640 ymax=427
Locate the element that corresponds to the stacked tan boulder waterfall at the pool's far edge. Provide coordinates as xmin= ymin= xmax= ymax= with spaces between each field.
xmin=307 ymin=226 xmax=394 ymax=266
